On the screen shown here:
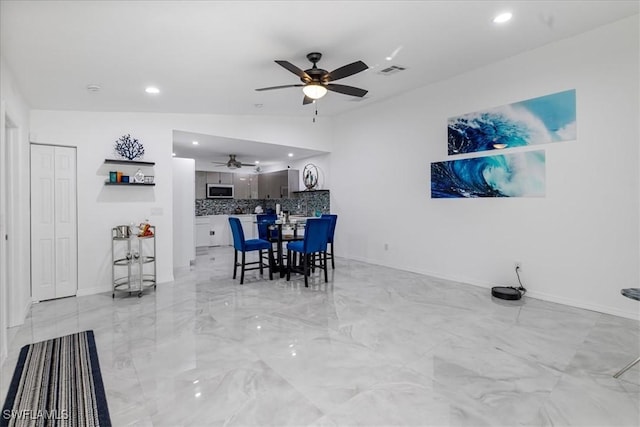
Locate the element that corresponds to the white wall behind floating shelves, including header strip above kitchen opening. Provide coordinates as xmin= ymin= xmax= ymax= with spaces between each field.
xmin=31 ymin=110 xmax=330 ymax=295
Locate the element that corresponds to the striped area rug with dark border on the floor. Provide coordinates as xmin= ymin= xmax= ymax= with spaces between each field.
xmin=0 ymin=331 xmax=111 ymax=427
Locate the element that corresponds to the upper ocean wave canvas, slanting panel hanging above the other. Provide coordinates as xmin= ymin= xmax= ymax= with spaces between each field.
xmin=448 ymin=89 xmax=576 ymax=155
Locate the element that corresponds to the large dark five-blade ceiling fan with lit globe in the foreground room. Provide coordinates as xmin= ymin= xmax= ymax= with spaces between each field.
xmin=256 ymin=52 xmax=369 ymax=105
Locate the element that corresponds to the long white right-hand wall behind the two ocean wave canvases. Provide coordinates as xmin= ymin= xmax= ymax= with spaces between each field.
xmin=331 ymin=16 xmax=640 ymax=318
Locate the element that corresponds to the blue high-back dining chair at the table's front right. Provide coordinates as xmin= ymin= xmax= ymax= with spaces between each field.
xmin=287 ymin=218 xmax=331 ymax=287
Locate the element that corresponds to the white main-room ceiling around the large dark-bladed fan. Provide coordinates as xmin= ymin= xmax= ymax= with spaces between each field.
xmin=0 ymin=0 xmax=639 ymax=165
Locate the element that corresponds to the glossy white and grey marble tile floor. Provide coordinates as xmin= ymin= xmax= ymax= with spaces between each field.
xmin=0 ymin=247 xmax=640 ymax=426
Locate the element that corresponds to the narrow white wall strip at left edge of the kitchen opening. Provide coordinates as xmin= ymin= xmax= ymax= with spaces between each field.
xmin=172 ymin=158 xmax=196 ymax=269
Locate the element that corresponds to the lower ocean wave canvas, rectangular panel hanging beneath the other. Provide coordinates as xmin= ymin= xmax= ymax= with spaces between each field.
xmin=431 ymin=150 xmax=546 ymax=199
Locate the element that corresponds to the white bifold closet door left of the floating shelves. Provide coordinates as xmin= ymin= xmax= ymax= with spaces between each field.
xmin=31 ymin=144 xmax=78 ymax=301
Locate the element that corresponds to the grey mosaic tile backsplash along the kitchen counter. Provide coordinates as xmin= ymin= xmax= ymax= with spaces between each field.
xmin=195 ymin=190 xmax=331 ymax=216
